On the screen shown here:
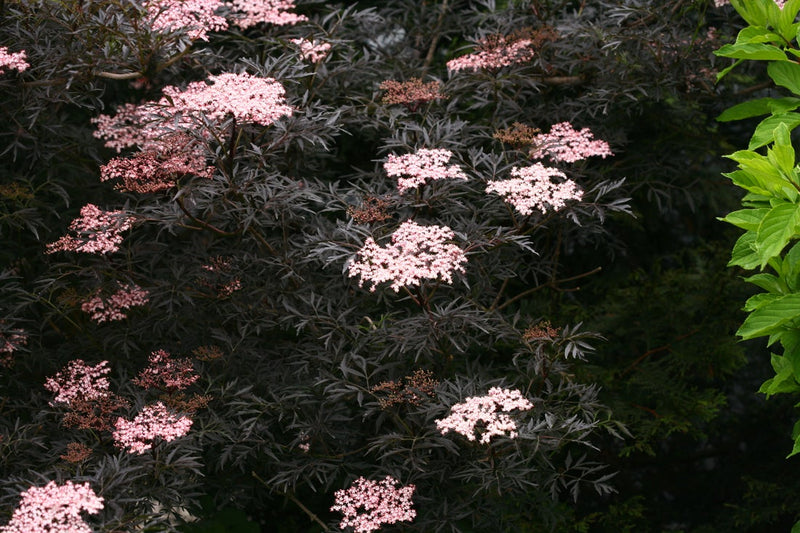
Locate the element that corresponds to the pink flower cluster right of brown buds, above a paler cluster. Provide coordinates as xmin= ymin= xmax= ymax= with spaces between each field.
xmin=531 ymin=122 xmax=614 ymax=163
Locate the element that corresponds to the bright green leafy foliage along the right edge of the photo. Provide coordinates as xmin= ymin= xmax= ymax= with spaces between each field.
xmin=717 ymin=0 xmax=800 ymax=460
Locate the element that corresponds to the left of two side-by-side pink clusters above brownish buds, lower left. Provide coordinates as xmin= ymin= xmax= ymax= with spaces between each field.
xmin=44 ymin=359 xmax=111 ymax=406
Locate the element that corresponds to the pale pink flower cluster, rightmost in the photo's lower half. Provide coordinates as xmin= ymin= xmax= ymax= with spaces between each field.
xmin=436 ymin=387 xmax=533 ymax=444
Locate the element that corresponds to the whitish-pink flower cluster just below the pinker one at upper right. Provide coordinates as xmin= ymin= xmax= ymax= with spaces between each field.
xmin=486 ymin=163 xmax=583 ymax=215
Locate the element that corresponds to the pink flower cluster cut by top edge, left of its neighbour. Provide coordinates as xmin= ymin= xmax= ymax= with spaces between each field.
xmin=144 ymin=0 xmax=228 ymax=41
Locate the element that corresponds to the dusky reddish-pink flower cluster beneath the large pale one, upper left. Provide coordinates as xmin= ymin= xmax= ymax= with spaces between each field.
xmin=100 ymin=134 xmax=214 ymax=193
